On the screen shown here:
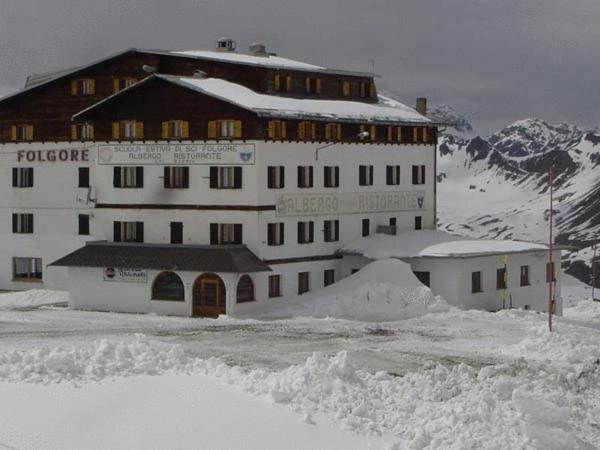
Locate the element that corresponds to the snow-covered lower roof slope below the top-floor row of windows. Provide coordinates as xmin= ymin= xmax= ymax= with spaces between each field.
xmin=156 ymin=75 xmax=431 ymax=124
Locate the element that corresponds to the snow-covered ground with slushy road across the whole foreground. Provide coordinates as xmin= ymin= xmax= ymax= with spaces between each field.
xmin=0 ymin=286 xmax=600 ymax=449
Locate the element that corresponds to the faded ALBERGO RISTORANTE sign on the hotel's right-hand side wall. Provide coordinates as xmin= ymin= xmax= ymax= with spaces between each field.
xmin=277 ymin=191 xmax=427 ymax=217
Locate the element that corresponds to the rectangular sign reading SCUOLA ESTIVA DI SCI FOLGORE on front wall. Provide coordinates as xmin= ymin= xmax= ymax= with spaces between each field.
xmin=98 ymin=143 xmax=255 ymax=166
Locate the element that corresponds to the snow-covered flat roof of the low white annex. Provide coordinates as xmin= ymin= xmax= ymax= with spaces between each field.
xmin=341 ymin=230 xmax=548 ymax=259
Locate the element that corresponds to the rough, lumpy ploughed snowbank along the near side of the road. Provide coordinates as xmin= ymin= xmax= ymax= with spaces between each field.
xmin=0 ymin=337 xmax=600 ymax=450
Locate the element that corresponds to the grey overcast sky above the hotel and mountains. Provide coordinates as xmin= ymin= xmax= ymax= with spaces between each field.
xmin=0 ymin=0 xmax=600 ymax=134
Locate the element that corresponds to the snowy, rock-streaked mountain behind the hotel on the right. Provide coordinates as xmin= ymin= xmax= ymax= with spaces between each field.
xmin=432 ymin=106 xmax=600 ymax=282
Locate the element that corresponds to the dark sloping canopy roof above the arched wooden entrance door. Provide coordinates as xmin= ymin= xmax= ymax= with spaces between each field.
xmin=50 ymin=241 xmax=271 ymax=273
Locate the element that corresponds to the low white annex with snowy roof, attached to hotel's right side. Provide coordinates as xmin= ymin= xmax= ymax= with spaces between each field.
xmin=341 ymin=230 xmax=562 ymax=315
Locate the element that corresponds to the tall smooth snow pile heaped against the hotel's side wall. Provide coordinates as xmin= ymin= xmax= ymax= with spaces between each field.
xmin=234 ymin=259 xmax=448 ymax=321
